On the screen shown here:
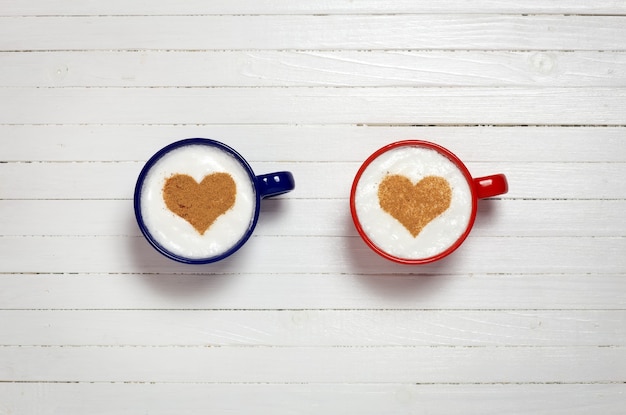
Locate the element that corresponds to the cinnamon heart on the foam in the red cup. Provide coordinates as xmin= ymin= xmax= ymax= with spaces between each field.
xmin=378 ymin=174 xmax=452 ymax=238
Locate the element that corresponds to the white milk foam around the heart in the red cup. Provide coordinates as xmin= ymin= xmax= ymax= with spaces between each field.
xmin=355 ymin=146 xmax=472 ymax=259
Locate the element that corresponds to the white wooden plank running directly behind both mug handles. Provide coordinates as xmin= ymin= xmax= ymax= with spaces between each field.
xmin=0 ymin=161 xmax=626 ymax=200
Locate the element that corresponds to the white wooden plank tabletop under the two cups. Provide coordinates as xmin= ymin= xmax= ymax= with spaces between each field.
xmin=0 ymin=0 xmax=626 ymax=415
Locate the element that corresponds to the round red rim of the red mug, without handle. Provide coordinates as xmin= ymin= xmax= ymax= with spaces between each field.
xmin=350 ymin=140 xmax=478 ymax=265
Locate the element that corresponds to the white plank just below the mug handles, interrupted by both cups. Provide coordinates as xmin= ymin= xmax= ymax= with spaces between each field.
xmin=0 ymin=198 xmax=626 ymax=237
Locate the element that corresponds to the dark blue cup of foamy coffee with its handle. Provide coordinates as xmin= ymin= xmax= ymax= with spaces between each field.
xmin=134 ymin=138 xmax=295 ymax=264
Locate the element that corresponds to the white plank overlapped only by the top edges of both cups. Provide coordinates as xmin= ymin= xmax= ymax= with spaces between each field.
xmin=0 ymin=124 xmax=626 ymax=163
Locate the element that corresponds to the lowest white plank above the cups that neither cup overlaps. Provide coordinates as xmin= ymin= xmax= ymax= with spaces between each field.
xmin=0 ymin=87 xmax=626 ymax=126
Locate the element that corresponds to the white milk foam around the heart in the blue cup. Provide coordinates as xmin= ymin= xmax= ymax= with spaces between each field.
xmin=141 ymin=144 xmax=256 ymax=259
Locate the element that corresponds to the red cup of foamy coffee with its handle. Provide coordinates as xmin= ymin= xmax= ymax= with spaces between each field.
xmin=350 ymin=140 xmax=508 ymax=264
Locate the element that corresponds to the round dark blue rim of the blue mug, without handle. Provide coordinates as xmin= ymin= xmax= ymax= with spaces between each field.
xmin=133 ymin=137 xmax=261 ymax=264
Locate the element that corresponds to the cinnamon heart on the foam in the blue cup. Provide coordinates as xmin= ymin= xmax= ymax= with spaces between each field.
xmin=163 ymin=173 xmax=237 ymax=235
